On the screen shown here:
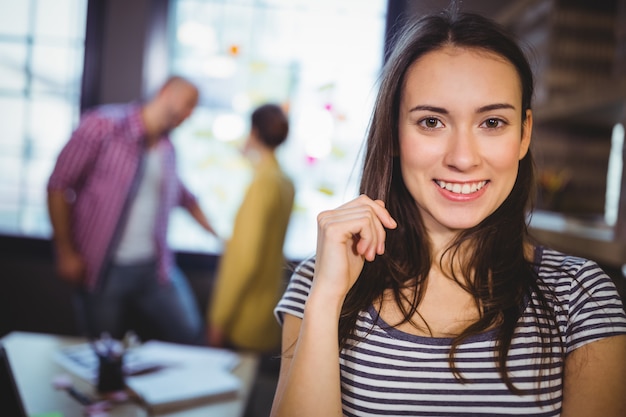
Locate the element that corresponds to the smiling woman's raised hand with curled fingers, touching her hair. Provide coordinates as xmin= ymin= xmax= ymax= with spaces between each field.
xmin=314 ymin=195 xmax=397 ymax=301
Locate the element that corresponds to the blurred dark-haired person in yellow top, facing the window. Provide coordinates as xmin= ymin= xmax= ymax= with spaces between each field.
xmin=207 ymin=104 xmax=295 ymax=352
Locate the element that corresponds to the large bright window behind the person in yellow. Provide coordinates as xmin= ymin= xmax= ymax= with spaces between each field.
xmin=169 ymin=0 xmax=387 ymax=259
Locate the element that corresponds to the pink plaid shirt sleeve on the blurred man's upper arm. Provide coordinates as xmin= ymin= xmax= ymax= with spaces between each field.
xmin=47 ymin=111 xmax=114 ymax=191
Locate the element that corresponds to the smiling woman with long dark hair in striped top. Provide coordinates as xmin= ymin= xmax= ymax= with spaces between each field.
xmin=272 ymin=5 xmax=626 ymax=417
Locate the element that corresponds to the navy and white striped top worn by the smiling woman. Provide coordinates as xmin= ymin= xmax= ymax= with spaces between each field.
xmin=275 ymin=248 xmax=626 ymax=417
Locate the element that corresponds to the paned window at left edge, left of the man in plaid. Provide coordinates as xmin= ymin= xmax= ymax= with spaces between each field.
xmin=0 ymin=0 xmax=87 ymax=237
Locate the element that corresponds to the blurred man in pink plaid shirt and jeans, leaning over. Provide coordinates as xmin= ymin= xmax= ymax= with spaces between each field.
xmin=48 ymin=77 xmax=214 ymax=344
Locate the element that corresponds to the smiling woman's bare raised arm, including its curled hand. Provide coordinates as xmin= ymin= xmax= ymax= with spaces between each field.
xmin=271 ymin=196 xmax=396 ymax=417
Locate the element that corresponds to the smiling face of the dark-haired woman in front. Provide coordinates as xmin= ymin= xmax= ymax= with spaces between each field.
xmin=398 ymin=46 xmax=532 ymax=238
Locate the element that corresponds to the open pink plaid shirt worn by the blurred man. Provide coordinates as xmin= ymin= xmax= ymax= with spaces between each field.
xmin=48 ymin=103 xmax=196 ymax=289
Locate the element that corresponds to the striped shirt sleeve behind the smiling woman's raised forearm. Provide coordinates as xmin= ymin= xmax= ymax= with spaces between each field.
xmin=274 ymin=257 xmax=315 ymax=326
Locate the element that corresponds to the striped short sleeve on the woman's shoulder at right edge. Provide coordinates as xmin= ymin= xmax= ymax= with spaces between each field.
xmin=565 ymin=261 xmax=626 ymax=353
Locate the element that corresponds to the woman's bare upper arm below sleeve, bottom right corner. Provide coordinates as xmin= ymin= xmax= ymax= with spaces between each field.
xmin=561 ymin=335 xmax=626 ymax=417
